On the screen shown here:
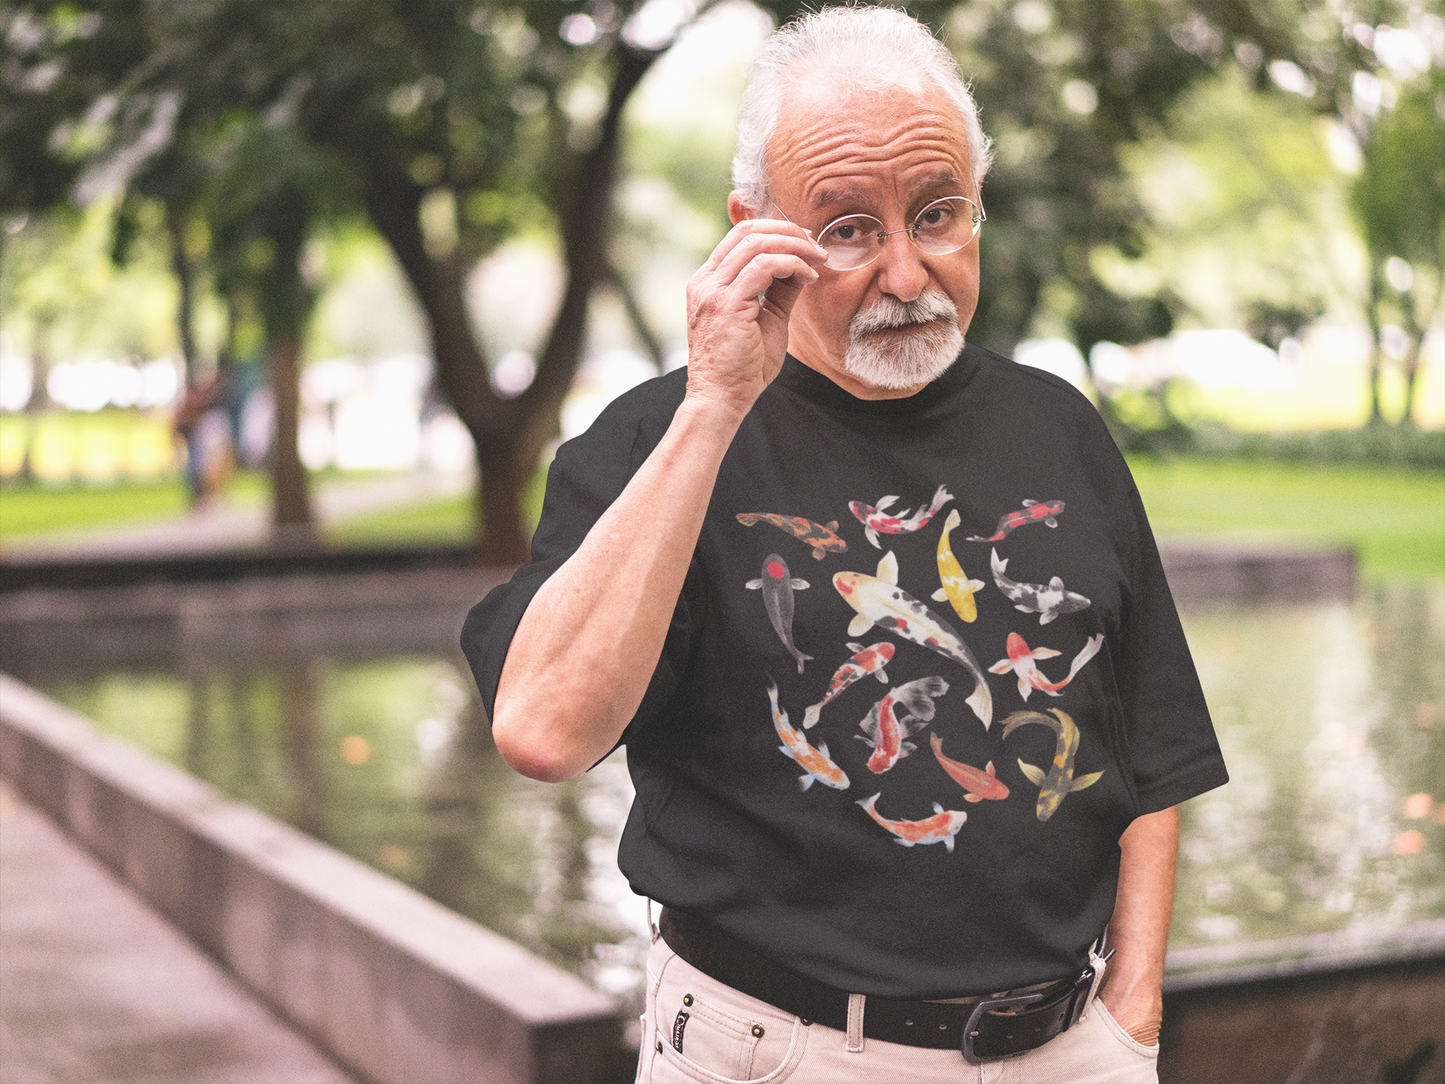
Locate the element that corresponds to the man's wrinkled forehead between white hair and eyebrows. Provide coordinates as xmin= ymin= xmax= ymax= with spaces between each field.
xmin=767 ymin=79 xmax=972 ymax=212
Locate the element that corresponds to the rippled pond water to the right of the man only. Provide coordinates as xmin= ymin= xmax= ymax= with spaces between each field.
xmin=1170 ymin=582 xmax=1445 ymax=947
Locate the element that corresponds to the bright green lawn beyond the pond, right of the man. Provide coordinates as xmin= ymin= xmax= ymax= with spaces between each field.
xmin=1129 ymin=457 xmax=1445 ymax=577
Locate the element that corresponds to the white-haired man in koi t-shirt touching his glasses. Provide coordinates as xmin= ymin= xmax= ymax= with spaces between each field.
xmin=462 ymin=7 xmax=1225 ymax=1084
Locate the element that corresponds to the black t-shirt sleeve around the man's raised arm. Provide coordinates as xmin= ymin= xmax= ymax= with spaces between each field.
xmin=461 ymin=382 xmax=695 ymax=745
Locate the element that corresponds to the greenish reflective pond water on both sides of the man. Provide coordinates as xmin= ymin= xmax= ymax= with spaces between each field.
xmin=20 ymin=580 xmax=1445 ymax=996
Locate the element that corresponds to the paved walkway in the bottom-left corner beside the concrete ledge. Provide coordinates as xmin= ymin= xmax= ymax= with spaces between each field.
xmin=0 ymin=783 xmax=355 ymax=1084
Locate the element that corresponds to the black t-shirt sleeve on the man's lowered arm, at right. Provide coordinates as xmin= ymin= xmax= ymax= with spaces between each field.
xmin=1117 ymin=486 xmax=1230 ymax=815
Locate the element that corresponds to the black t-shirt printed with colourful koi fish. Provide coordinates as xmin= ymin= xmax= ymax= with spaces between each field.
xmin=462 ymin=345 xmax=1227 ymax=997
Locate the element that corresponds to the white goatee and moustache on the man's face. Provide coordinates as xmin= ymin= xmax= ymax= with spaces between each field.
xmin=842 ymin=293 xmax=964 ymax=390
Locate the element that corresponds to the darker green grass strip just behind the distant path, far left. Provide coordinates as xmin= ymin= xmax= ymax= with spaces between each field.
xmin=0 ymin=471 xmax=267 ymax=541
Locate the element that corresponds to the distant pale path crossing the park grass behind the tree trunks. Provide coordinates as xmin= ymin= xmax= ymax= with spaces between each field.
xmin=4 ymin=471 xmax=473 ymax=559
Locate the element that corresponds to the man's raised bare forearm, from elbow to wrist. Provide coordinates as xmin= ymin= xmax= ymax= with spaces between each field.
xmin=493 ymin=402 xmax=740 ymax=782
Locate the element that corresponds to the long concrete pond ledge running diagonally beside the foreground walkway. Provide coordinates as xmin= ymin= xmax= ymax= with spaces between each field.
xmin=0 ymin=674 xmax=617 ymax=1084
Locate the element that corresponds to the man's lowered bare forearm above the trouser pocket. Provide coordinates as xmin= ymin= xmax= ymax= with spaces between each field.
xmin=1100 ymin=805 xmax=1179 ymax=1045
